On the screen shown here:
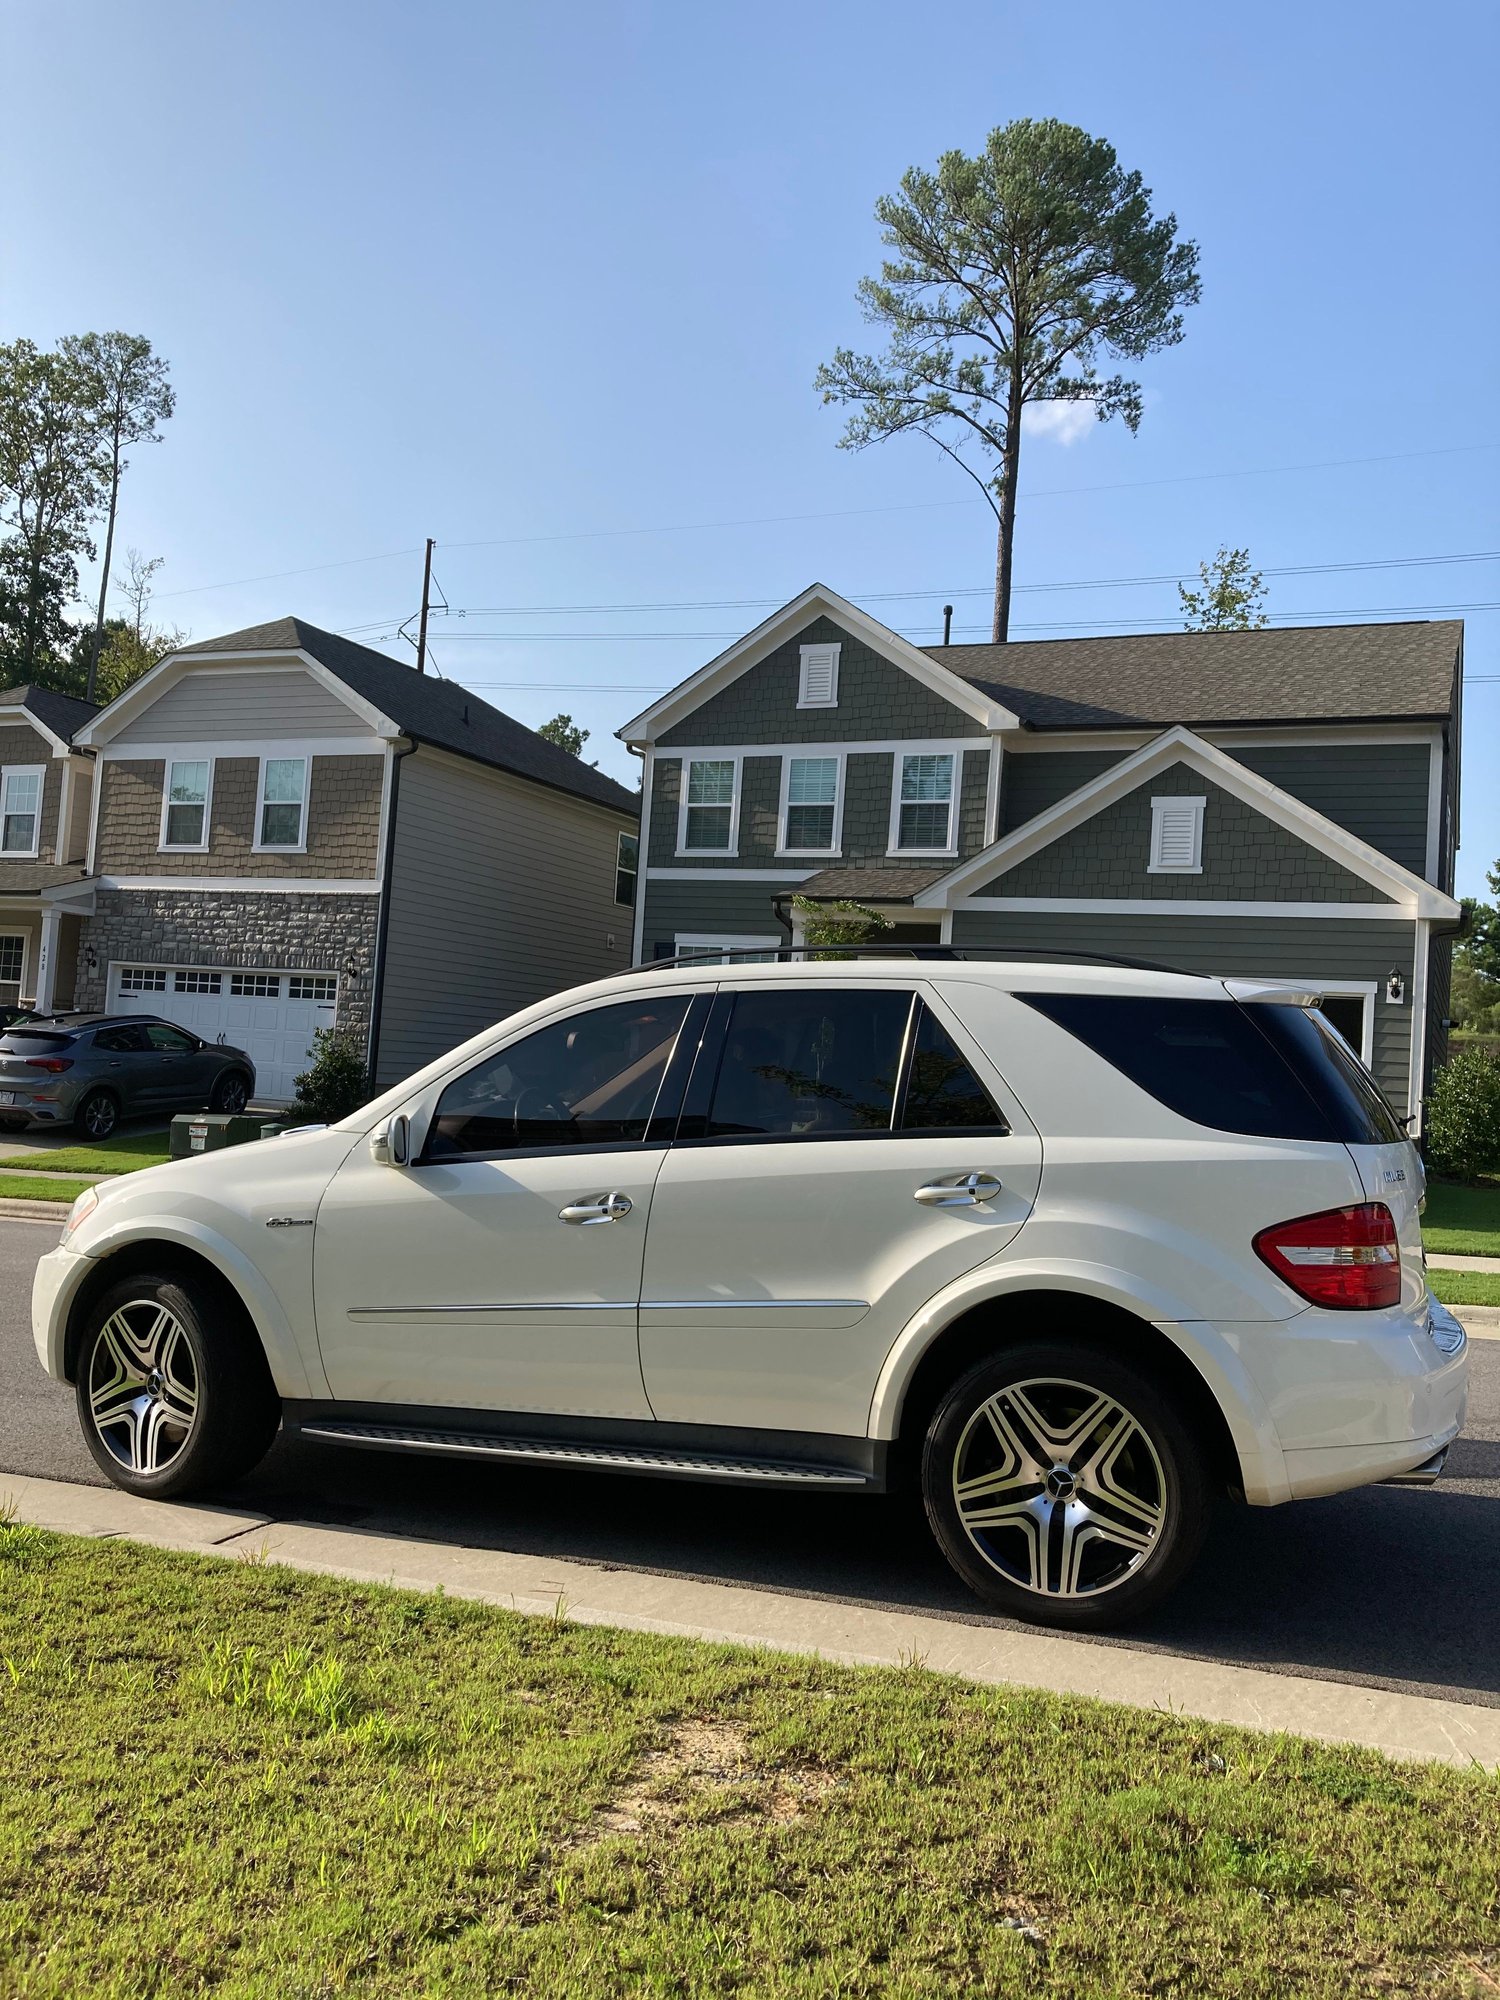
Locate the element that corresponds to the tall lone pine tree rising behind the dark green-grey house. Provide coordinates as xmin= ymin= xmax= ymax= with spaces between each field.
xmin=816 ymin=118 xmax=1200 ymax=640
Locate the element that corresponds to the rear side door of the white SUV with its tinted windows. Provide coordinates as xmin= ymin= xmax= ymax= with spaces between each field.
xmin=640 ymin=978 xmax=1042 ymax=1436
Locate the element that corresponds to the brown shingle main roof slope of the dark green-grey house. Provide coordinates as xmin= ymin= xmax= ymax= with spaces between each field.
xmin=922 ymin=618 xmax=1464 ymax=730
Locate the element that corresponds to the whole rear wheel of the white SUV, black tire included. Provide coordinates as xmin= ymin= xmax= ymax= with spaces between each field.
xmin=922 ymin=1334 xmax=1210 ymax=1632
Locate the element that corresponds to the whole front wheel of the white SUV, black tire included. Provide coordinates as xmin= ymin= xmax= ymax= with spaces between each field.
xmin=74 ymin=1266 xmax=282 ymax=1500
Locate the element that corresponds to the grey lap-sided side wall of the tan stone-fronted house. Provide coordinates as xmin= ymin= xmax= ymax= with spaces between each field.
xmin=378 ymin=750 xmax=636 ymax=1084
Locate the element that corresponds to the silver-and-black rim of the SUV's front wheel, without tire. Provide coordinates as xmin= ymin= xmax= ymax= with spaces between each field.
xmin=88 ymin=1298 xmax=198 ymax=1476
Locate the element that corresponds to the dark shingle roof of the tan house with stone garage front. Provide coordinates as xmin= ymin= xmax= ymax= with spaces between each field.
xmin=83 ymin=618 xmax=640 ymax=816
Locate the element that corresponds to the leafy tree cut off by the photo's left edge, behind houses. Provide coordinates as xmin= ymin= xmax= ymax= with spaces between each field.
xmin=0 ymin=340 xmax=102 ymax=684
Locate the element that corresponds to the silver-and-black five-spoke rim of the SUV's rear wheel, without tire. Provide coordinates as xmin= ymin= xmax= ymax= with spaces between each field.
xmin=952 ymin=1378 xmax=1168 ymax=1598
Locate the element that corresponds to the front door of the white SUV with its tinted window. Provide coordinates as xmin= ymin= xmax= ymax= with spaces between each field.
xmin=314 ymin=992 xmax=708 ymax=1418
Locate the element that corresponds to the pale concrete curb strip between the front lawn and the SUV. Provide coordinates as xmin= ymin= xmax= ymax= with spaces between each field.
xmin=11 ymin=1474 xmax=1500 ymax=1766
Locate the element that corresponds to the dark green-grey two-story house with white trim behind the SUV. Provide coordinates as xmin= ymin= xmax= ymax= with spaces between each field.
xmin=620 ymin=586 xmax=1462 ymax=1130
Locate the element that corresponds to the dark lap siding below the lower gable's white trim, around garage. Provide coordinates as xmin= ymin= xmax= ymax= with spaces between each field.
xmin=952 ymin=910 xmax=1414 ymax=1110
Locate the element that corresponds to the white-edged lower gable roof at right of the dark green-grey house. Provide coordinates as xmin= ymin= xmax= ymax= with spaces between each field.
xmin=928 ymin=728 xmax=1460 ymax=924
